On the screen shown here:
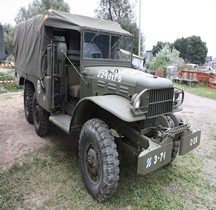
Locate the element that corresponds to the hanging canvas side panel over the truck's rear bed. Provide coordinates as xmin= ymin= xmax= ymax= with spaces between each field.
xmin=14 ymin=16 xmax=45 ymax=77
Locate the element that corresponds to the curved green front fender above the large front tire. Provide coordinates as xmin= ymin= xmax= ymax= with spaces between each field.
xmin=71 ymin=95 xmax=146 ymax=127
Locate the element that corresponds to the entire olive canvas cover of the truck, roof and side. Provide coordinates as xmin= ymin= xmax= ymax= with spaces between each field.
xmin=14 ymin=10 xmax=131 ymax=77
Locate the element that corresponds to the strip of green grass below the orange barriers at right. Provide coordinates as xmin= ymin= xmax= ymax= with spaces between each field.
xmin=174 ymin=83 xmax=216 ymax=100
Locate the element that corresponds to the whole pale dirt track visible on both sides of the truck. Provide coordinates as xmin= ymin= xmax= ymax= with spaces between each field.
xmin=0 ymin=92 xmax=216 ymax=175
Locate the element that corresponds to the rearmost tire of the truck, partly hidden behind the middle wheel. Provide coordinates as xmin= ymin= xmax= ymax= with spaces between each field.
xmin=24 ymin=82 xmax=34 ymax=124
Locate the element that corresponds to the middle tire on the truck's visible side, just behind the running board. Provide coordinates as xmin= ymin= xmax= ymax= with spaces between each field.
xmin=33 ymin=93 xmax=49 ymax=137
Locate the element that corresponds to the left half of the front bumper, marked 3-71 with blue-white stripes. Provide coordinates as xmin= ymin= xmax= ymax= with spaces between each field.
xmin=137 ymin=142 xmax=173 ymax=175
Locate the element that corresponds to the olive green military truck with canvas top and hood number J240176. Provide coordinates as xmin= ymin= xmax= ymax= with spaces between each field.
xmin=14 ymin=10 xmax=201 ymax=202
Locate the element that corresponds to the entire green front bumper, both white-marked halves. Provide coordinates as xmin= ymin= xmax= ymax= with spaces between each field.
xmin=137 ymin=130 xmax=201 ymax=175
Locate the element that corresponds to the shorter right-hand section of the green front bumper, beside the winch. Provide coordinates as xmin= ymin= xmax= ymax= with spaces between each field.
xmin=179 ymin=130 xmax=201 ymax=155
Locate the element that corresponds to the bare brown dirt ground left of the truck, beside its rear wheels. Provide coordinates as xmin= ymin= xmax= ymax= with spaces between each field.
xmin=0 ymin=92 xmax=71 ymax=171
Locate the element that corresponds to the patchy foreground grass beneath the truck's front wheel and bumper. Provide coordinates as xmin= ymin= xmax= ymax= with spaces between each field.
xmin=0 ymin=142 xmax=216 ymax=210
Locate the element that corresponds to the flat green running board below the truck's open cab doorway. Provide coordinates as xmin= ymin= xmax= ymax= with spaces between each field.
xmin=49 ymin=114 xmax=72 ymax=134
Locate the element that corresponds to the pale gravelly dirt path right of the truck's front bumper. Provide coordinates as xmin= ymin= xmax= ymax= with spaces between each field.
xmin=180 ymin=91 xmax=216 ymax=184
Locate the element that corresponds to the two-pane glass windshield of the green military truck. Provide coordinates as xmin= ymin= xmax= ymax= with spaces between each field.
xmin=83 ymin=31 xmax=133 ymax=61
